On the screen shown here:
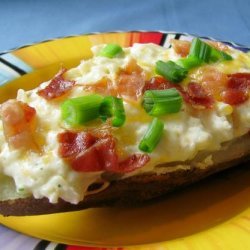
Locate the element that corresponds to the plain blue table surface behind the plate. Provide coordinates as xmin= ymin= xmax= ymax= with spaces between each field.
xmin=0 ymin=0 xmax=250 ymax=51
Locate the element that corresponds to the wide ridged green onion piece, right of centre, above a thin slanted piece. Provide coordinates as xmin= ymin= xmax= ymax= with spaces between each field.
xmin=143 ymin=88 xmax=182 ymax=116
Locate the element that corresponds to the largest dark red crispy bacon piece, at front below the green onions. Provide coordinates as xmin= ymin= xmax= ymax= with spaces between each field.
xmin=58 ymin=131 xmax=149 ymax=173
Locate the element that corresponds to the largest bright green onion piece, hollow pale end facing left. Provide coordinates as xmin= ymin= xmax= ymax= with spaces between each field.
xmin=61 ymin=94 xmax=103 ymax=126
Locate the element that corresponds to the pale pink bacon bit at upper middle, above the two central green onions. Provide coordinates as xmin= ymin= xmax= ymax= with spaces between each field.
xmin=117 ymin=60 xmax=145 ymax=100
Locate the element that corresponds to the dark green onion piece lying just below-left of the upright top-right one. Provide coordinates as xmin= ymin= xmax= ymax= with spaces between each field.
xmin=156 ymin=61 xmax=188 ymax=83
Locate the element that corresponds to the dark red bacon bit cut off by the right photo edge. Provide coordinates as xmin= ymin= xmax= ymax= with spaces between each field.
xmin=222 ymin=73 xmax=250 ymax=105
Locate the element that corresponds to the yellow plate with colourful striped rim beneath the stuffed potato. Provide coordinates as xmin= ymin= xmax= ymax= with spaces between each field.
xmin=0 ymin=32 xmax=250 ymax=250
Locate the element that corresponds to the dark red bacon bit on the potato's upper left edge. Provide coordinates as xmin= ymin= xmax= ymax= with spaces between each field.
xmin=38 ymin=68 xmax=75 ymax=100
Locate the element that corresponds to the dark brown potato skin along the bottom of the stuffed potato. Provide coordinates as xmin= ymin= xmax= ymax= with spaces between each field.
xmin=0 ymin=154 xmax=250 ymax=216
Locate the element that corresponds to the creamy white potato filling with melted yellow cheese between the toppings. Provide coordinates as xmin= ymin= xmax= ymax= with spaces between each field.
xmin=0 ymin=44 xmax=250 ymax=203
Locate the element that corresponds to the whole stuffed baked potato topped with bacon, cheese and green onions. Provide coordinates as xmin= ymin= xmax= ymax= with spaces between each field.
xmin=0 ymin=39 xmax=250 ymax=215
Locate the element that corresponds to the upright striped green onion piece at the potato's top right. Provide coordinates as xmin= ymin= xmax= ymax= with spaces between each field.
xmin=189 ymin=38 xmax=212 ymax=63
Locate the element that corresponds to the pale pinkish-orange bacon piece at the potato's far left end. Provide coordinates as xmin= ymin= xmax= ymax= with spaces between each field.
xmin=0 ymin=100 xmax=38 ymax=151
